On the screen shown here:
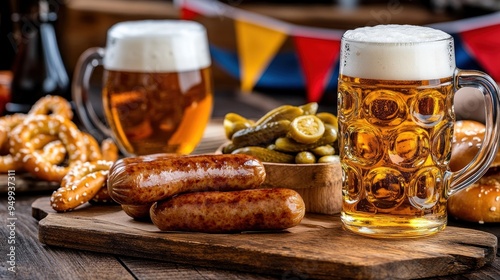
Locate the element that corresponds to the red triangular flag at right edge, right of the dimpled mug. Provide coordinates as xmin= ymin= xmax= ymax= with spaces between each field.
xmin=460 ymin=24 xmax=500 ymax=81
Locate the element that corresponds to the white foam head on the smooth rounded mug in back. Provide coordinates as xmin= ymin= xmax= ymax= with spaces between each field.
xmin=103 ymin=20 xmax=210 ymax=73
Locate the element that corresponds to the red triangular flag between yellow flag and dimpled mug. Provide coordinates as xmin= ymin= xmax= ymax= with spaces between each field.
xmin=294 ymin=36 xmax=340 ymax=102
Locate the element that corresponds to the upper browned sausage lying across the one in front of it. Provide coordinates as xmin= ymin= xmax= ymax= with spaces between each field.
xmin=108 ymin=154 xmax=266 ymax=205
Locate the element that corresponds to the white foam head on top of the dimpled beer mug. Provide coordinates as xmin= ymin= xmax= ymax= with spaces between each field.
xmin=340 ymin=25 xmax=455 ymax=80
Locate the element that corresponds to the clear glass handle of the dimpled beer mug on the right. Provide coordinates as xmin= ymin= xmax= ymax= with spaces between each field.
xmin=445 ymin=69 xmax=500 ymax=195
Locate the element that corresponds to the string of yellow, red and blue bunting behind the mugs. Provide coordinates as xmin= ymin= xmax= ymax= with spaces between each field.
xmin=175 ymin=0 xmax=500 ymax=102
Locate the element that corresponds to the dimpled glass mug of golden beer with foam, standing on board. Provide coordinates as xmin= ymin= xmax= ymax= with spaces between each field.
xmin=338 ymin=25 xmax=500 ymax=238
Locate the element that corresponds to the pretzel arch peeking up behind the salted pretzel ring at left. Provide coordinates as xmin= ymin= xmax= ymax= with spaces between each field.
xmin=28 ymin=95 xmax=73 ymax=120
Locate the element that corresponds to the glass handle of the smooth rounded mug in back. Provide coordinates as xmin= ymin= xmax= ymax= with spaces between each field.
xmin=72 ymin=47 xmax=111 ymax=138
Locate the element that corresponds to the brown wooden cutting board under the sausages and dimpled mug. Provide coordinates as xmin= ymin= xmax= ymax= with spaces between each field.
xmin=32 ymin=197 xmax=497 ymax=279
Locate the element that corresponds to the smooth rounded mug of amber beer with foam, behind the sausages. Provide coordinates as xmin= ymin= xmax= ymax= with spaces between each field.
xmin=72 ymin=20 xmax=213 ymax=155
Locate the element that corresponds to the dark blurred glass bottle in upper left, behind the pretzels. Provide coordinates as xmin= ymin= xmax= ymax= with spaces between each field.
xmin=5 ymin=0 xmax=70 ymax=114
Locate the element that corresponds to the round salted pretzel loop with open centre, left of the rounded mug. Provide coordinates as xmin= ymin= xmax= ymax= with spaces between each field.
xmin=10 ymin=115 xmax=87 ymax=182
